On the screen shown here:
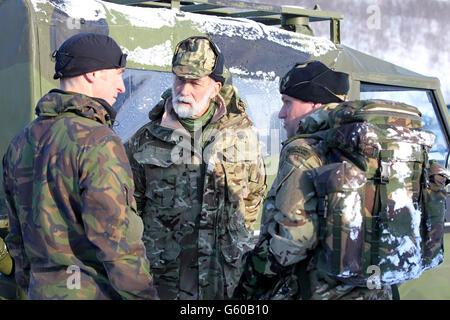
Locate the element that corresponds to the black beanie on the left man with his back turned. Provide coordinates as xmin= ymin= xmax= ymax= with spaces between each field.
xmin=52 ymin=33 xmax=127 ymax=79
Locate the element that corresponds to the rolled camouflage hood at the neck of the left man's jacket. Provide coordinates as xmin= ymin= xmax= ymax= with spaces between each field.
xmin=35 ymin=89 xmax=116 ymax=127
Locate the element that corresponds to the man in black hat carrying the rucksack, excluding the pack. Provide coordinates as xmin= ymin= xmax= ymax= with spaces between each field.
xmin=234 ymin=61 xmax=391 ymax=300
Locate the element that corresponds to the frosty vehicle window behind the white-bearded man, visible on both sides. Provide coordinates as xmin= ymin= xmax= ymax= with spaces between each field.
xmin=114 ymin=69 xmax=286 ymax=157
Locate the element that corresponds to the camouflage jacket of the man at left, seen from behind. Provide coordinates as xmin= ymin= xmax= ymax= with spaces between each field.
xmin=3 ymin=90 xmax=157 ymax=299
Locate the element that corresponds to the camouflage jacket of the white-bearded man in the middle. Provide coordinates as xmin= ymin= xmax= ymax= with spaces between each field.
xmin=127 ymin=86 xmax=266 ymax=299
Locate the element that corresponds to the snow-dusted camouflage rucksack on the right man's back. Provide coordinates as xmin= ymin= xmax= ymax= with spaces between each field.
xmin=294 ymin=100 xmax=450 ymax=288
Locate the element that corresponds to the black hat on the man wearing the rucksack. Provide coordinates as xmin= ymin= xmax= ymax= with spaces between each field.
xmin=280 ymin=61 xmax=349 ymax=103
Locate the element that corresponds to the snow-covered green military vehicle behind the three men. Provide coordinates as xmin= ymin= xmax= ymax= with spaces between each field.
xmin=0 ymin=0 xmax=450 ymax=299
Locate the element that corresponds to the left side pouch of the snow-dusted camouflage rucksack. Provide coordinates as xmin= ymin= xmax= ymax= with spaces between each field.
xmin=312 ymin=163 xmax=367 ymax=280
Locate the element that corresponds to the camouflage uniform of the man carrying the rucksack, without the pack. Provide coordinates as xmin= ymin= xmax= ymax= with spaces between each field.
xmin=234 ymin=103 xmax=392 ymax=300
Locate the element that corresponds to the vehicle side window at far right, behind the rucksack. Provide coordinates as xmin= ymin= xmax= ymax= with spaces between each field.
xmin=360 ymin=83 xmax=449 ymax=165
